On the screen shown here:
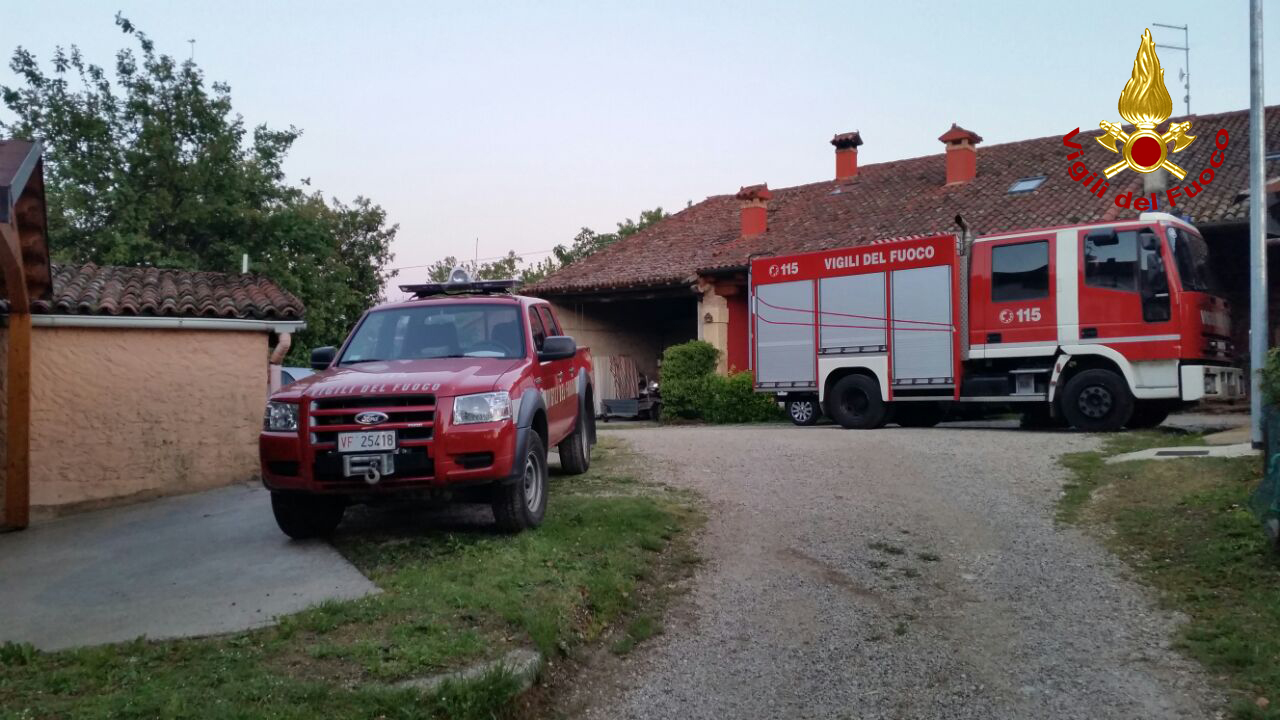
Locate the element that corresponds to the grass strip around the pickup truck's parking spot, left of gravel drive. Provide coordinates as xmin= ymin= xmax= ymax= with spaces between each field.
xmin=0 ymin=438 xmax=699 ymax=720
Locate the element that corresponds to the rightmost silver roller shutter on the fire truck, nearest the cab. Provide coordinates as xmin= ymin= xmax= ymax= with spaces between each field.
xmin=892 ymin=265 xmax=955 ymax=384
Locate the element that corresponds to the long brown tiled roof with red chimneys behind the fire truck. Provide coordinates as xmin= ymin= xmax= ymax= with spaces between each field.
xmin=526 ymin=106 xmax=1280 ymax=295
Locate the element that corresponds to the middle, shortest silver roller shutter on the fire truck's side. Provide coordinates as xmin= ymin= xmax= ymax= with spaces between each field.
xmin=818 ymin=273 xmax=887 ymax=352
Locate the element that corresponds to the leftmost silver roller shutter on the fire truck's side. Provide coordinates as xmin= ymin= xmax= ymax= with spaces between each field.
xmin=755 ymin=281 xmax=817 ymax=387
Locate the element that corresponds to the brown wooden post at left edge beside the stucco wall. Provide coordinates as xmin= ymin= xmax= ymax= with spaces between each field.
xmin=0 ymin=224 xmax=31 ymax=530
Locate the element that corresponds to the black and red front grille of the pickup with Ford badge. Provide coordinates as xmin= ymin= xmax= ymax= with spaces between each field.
xmin=307 ymin=395 xmax=435 ymax=486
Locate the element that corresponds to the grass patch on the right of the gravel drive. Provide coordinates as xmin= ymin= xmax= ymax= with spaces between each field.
xmin=1059 ymin=433 xmax=1280 ymax=720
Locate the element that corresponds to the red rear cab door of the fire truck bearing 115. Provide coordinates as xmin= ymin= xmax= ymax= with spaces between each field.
xmin=969 ymin=233 xmax=1057 ymax=356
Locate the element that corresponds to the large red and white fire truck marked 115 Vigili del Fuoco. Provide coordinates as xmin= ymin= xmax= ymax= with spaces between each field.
xmin=749 ymin=213 xmax=1243 ymax=432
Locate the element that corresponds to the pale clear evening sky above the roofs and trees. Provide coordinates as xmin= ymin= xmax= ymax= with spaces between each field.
xmin=0 ymin=0 xmax=1280 ymax=282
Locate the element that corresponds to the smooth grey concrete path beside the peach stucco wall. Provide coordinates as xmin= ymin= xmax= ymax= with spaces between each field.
xmin=0 ymin=486 xmax=378 ymax=650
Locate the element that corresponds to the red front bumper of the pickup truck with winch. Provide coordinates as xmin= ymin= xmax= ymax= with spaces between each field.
xmin=259 ymin=398 xmax=519 ymax=495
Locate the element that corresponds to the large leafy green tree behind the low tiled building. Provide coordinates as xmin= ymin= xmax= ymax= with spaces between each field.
xmin=0 ymin=14 xmax=397 ymax=357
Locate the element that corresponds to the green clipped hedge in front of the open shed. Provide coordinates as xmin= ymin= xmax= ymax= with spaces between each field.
xmin=660 ymin=340 xmax=782 ymax=423
